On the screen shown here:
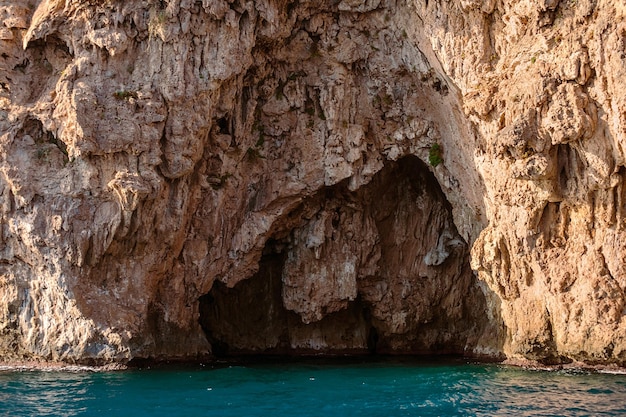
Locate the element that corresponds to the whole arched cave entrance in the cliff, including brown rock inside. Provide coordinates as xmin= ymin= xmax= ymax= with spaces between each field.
xmin=200 ymin=156 xmax=486 ymax=356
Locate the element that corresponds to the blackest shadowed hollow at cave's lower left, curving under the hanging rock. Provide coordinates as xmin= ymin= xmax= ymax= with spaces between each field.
xmin=200 ymin=247 xmax=371 ymax=357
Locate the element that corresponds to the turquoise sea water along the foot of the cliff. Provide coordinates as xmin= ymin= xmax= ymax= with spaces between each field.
xmin=0 ymin=360 xmax=626 ymax=417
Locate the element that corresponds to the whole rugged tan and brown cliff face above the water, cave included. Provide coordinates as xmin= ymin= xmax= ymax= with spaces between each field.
xmin=0 ymin=0 xmax=626 ymax=366
